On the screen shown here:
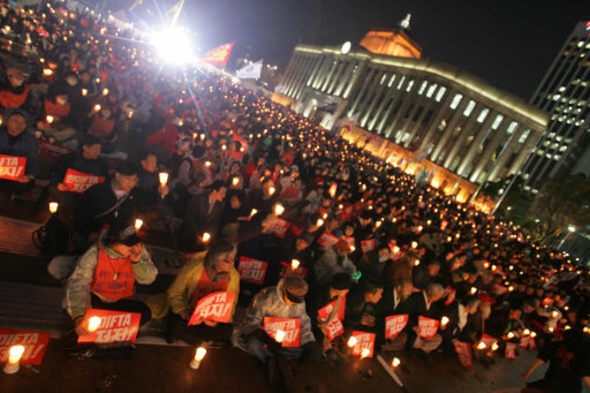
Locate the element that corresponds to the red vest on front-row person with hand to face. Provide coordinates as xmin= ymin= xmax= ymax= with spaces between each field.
xmin=90 ymin=244 xmax=135 ymax=302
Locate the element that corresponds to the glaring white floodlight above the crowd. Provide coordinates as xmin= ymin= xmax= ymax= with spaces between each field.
xmin=152 ymin=26 xmax=193 ymax=64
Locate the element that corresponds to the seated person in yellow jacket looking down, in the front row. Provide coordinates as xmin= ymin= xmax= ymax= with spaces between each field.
xmin=166 ymin=240 xmax=240 ymax=345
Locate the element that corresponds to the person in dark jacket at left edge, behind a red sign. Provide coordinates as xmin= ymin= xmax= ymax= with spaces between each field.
xmin=0 ymin=109 xmax=39 ymax=199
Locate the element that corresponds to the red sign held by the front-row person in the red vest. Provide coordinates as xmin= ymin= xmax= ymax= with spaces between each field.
xmin=78 ymin=308 xmax=141 ymax=344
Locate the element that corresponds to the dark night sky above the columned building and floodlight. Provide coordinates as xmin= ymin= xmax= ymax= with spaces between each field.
xmin=123 ymin=0 xmax=590 ymax=99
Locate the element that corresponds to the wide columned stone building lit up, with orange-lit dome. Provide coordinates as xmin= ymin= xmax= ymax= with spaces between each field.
xmin=274 ymin=30 xmax=548 ymax=187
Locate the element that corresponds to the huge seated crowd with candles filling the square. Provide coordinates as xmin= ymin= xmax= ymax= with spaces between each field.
xmin=0 ymin=2 xmax=590 ymax=392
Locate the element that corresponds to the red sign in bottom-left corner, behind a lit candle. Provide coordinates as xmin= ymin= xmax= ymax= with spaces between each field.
xmin=0 ymin=329 xmax=50 ymax=364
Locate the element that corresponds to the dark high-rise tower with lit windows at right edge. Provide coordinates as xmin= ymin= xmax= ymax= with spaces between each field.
xmin=523 ymin=21 xmax=590 ymax=192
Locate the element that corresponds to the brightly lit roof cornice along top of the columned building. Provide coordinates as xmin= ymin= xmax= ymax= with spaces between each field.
xmin=295 ymin=44 xmax=549 ymax=129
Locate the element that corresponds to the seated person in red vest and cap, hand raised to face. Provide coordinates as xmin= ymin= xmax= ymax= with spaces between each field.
xmin=63 ymin=220 xmax=158 ymax=335
